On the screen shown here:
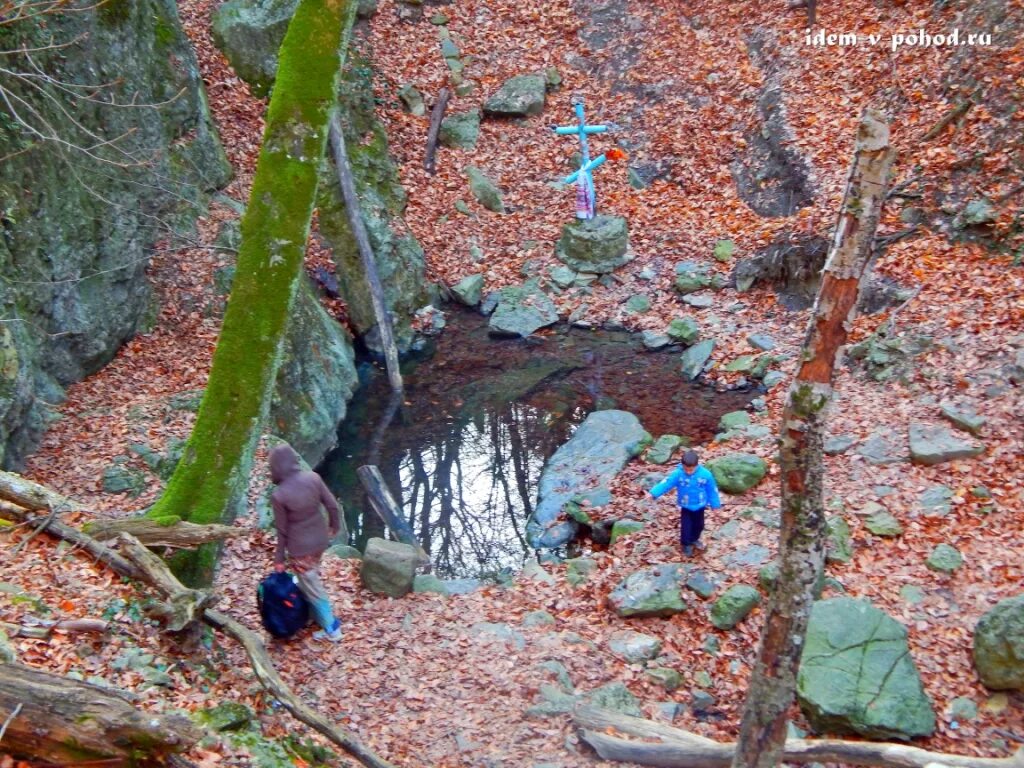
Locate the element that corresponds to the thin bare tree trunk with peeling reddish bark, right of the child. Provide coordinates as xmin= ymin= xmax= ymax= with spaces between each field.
xmin=732 ymin=110 xmax=895 ymax=768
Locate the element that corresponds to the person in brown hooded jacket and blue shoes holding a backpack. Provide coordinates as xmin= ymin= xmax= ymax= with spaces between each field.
xmin=270 ymin=445 xmax=341 ymax=642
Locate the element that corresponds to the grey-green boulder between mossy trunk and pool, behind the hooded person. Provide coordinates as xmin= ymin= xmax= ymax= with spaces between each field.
xmin=270 ymin=280 xmax=358 ymax=466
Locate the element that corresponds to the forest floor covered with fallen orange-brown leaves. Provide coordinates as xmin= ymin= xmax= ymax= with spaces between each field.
xmin=0 ymin=0 xmax=1024 ymax=768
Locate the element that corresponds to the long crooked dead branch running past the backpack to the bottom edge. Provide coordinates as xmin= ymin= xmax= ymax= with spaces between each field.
xmin=0 ymin=495 xmax=394 ymax=768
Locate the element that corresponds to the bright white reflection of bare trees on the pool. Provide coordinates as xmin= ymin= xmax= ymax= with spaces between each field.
xmin=381 ymin=403 xmax=571 ymax=578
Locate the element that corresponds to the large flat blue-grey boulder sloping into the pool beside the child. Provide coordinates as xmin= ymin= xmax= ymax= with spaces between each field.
xmin=526 ymin=411 xmax=650 ymax=548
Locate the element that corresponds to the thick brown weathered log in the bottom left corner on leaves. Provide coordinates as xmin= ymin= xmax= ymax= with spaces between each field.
xmin=0 ymin=664 xmax=203 ymax=765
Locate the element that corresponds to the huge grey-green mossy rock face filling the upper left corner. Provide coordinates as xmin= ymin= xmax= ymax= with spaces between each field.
xmin=0 ymin=0 xmax=230 ymax=468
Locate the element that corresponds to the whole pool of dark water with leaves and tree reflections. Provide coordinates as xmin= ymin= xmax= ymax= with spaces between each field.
xmin=318 ymin=309 xmax=755 ymax=579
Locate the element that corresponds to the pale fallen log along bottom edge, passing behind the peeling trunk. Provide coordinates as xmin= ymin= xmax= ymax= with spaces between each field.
xmin=572 ymin=707 xmax=1024 ymax=768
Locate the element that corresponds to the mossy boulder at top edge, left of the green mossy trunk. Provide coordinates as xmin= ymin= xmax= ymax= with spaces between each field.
xmin=211 ymin=0 xmax=299 ymax=96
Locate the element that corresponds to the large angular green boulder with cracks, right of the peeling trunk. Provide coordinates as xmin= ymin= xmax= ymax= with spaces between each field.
xmin=797 ymin=597 xmax=935 ymax=739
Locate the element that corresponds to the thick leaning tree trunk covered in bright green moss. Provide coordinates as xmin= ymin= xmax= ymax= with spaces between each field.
xmin=150 ymin=0 xmax=355 ymax=585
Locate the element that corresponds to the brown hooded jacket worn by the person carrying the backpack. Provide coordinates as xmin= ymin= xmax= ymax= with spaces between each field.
xmin=270 ymin=445 xmax=339 ymax=563
